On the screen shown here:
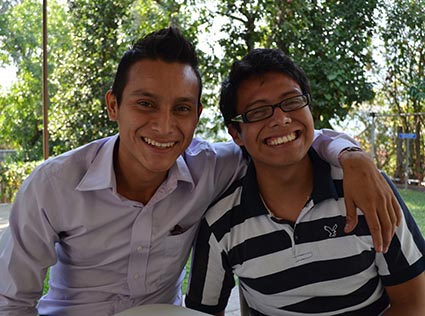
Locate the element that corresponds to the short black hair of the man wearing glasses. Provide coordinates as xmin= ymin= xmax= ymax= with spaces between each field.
xmin=220 ymin=48 xmax=310 ymax=130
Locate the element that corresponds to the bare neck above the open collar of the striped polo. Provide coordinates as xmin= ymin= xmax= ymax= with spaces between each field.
xmin=256 ymin=155 xmax=313 ymax=222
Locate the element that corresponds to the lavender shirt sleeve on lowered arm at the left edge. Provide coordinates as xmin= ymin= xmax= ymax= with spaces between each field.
xmin=0 ymin=167 xmax=57 ymax=316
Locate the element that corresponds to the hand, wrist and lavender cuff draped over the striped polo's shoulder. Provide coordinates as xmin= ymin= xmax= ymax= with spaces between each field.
xmin=313 ymin=129 xmax=401 ymax=252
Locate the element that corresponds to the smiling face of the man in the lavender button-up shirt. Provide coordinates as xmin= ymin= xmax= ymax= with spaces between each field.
xmin=106 ymin=59 xmax=202 ymax=183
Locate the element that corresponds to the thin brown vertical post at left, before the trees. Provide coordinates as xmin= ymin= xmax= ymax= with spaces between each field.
xmin=43 ymin=0 xmax=49 ymax=159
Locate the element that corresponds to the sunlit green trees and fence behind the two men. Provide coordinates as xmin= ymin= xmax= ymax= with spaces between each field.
xmin=0 ymin=0 xmax=425 ymax=203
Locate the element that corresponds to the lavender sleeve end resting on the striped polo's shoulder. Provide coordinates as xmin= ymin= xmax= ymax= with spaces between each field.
xmin=312 ymin=129 xmax=360 ymax=167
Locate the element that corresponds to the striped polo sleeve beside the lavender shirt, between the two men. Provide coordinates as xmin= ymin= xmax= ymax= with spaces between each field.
xmin=185 ymin=219 xmax=235 ymax=314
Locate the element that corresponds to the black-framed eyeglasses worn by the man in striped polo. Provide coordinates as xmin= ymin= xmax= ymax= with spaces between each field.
xmin=231 ymin=93 xmax=311 ymax=123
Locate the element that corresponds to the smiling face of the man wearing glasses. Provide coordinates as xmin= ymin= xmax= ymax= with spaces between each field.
xmin=229 ymin=72 xmax=314 ymax=173
